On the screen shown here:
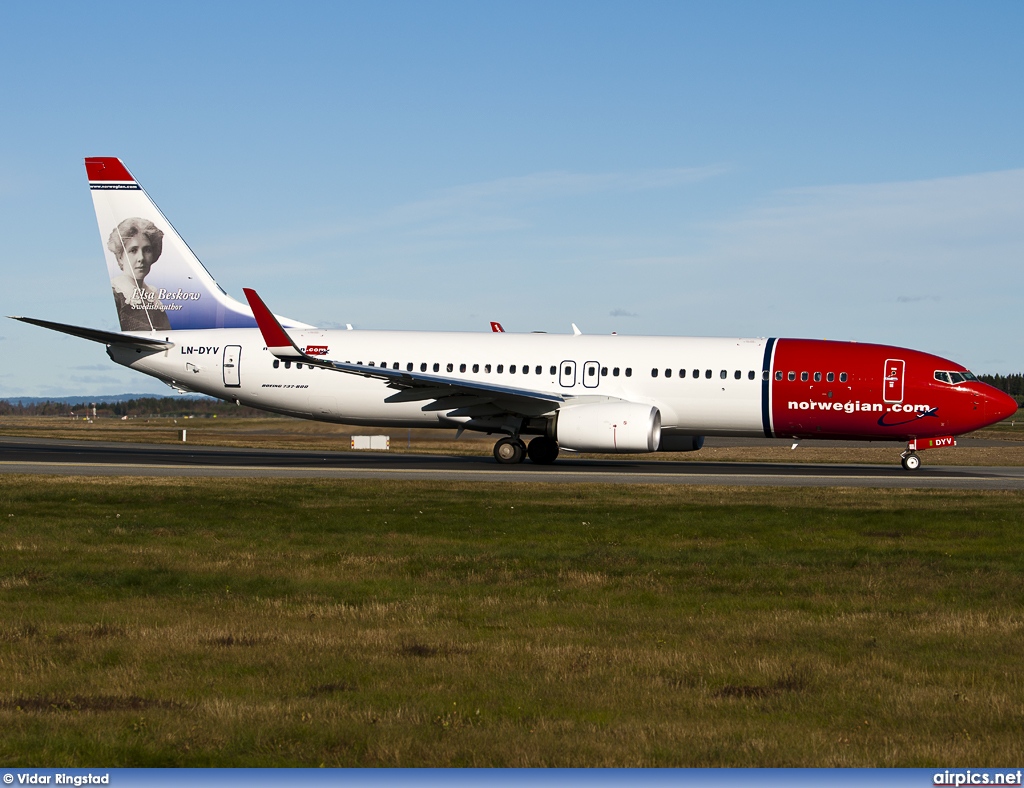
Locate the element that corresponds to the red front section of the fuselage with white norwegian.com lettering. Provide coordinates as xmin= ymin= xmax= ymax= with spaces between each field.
xmin=771 ymin=339 xmax=1017 ymax=440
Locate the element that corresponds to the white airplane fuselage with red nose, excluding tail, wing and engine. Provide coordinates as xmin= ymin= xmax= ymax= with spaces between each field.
xmin=110 ymin=329 xmax=1013 ymax=450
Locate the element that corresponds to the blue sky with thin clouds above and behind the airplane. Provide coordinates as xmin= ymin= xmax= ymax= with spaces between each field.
xmin=0 ymin=2 xmax=1024 ymax=396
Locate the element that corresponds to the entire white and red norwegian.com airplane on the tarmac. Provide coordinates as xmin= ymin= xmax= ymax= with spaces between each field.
xmin=16 ymin=158 xmax=1017 ymax=470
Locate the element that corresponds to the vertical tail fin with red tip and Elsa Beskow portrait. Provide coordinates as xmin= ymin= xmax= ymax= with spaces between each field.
xmin=85 ymin=158 xmax=302 ymax=332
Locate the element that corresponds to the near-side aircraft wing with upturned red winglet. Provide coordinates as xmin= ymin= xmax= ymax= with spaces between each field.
xmin=242 ymin=288 xmax=565 ymax=418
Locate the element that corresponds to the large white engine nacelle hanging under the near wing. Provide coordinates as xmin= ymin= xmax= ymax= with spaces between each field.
xmin=554 ymin=402 xmax=662 ymax=453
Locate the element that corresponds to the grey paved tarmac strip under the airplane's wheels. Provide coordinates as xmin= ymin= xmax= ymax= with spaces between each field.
xmin=0 ymin=437 xmax=1024 ymax=489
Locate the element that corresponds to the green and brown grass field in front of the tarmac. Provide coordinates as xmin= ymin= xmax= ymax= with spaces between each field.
xmin=0 ymin=476 xmax=1024 ymax=768
